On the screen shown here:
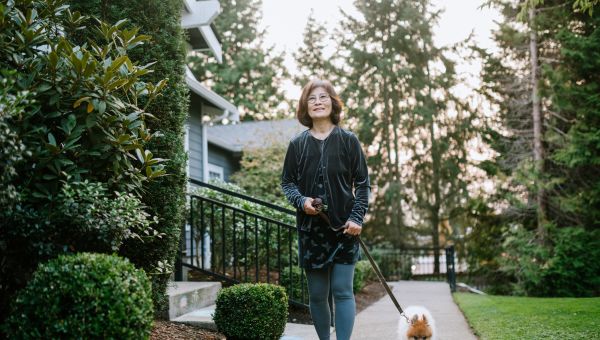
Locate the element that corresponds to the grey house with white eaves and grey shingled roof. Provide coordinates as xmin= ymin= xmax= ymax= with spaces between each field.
xmin=181 ymin=0 xmax=305 ymax=185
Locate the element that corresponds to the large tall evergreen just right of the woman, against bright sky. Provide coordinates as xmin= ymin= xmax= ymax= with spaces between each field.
xmin=340 ymin=0 xmax=474 ymax=271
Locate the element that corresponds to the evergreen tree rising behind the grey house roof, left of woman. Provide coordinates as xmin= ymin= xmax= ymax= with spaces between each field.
xmin=188 ymin=0 xmax=288 ymax=120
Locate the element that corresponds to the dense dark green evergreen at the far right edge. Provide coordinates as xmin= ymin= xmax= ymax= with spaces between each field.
xmin=546 ymin=5 xmax=600 ymax=230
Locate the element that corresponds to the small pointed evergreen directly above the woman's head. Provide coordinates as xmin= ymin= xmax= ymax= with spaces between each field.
xmin=293 ymin=11 xmax=335 ymax=86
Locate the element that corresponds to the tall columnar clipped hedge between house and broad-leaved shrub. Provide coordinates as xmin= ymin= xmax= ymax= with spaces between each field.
xmin=71 ymin=0 xmax=188 ymax=313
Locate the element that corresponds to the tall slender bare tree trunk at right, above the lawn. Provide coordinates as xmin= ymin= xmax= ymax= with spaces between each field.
xmin=529 ymin=6 xmax=546 ymax=243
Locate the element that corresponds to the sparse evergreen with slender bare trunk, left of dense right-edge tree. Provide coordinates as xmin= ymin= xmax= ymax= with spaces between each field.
xmin=481 ymin=0 xmax=556 ymax=228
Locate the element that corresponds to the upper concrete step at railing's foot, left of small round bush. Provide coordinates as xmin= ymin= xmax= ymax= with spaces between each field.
xmin=167 ymin=281 xmax=221 ymax=320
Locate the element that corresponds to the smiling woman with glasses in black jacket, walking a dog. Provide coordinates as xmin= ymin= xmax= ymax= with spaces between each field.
xmin=281 ymin=80 xmax=370 ymax=340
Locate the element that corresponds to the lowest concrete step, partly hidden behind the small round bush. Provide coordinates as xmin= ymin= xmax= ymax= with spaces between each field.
xmin=171 ymin=305 xmax=334 ymax=340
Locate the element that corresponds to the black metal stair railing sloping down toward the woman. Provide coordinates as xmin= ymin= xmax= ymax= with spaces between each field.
xmin=180 ymin=181 xmax=308 ymax=307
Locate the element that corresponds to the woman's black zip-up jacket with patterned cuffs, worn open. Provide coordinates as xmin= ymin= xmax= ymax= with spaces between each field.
xmin=281 ymin=126 xmax=371 ymax=231
